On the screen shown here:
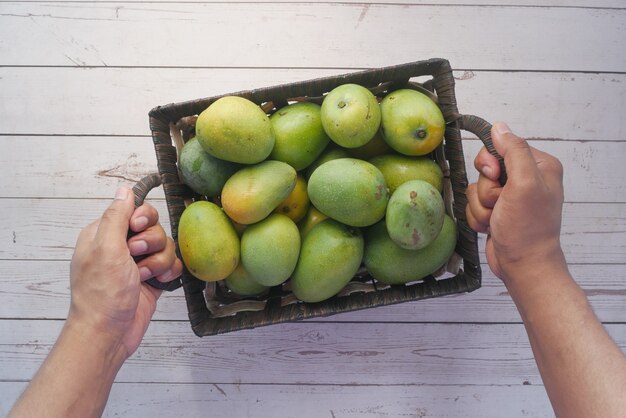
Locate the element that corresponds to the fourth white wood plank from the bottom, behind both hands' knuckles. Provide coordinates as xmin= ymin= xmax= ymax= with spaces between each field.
xmin=0 ymin=199 xmax=626 ymax=264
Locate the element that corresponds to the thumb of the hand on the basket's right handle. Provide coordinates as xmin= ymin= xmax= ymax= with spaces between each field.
xmin=491 ymin=122 xmax=537 ymax=185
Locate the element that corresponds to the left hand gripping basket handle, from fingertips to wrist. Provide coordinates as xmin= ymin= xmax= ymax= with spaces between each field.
xmin=68 ymin=188 xmax=182 ymax=359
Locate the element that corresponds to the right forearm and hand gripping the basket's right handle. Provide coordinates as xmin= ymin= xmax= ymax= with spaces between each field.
xmin=466 ymin=124 xmax=626 ymax=418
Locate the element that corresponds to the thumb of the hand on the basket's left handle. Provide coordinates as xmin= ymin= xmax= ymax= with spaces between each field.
xmin=96 ymin=187 xmax=135 ymax=242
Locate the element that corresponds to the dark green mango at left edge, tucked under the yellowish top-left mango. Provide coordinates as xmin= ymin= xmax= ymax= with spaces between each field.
xmin=178 ymin=137 xmax=240 ymax=197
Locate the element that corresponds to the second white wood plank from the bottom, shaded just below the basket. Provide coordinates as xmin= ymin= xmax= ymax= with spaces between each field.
xmin=0 ymin=320 xmax=626 ymax=385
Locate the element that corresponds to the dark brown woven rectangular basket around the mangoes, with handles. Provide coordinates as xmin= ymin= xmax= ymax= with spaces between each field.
xmin=139 ymin=59 xmax=493 ymax=336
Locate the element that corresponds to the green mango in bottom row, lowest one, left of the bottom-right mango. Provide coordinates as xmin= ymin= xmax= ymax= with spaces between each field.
xmin=291 ymin=219 xmax=364 ymax=302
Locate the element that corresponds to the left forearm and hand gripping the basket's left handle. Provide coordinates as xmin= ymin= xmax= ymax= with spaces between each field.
xmin=9 ymin=188 xmax=182 ymax=418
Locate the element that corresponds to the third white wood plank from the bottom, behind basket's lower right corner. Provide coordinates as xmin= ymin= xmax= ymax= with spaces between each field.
xmin=0 ymin=260 xmax=626 ymax=323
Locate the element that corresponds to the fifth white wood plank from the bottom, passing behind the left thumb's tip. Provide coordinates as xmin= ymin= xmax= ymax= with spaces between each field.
xmin=0 ymin=134 xmax=626 ymax=202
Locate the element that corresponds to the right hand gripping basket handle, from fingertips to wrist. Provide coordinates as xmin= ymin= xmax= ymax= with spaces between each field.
xmin=466 ymin=123 xmax=565 ymax=283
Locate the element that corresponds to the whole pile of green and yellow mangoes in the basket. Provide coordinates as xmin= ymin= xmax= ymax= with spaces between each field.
xmin=178 ymin=84 xmax=457 ymax=302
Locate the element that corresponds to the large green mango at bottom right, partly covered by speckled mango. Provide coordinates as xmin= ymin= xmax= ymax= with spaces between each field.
xmin=363 ymin=215 xmax=457 ymax=284
